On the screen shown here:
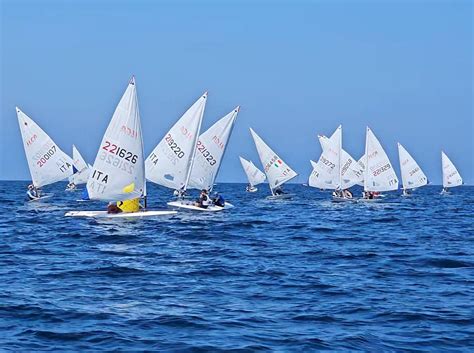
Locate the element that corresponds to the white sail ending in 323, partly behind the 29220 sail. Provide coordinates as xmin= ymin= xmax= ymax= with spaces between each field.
xmin=188 ymin=107 xmax=239 ymax=191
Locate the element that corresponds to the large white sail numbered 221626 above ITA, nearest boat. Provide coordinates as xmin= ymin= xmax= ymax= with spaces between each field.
xmin=87 ymin=77 xmax=145 ymax=201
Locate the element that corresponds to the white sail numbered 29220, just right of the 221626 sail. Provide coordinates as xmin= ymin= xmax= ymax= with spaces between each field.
xmin=145 ymin=92 xmax=207 ymax=191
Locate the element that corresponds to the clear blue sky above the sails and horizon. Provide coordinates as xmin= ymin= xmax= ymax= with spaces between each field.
xmin=0 ymin=0 xmax=474 ymax=184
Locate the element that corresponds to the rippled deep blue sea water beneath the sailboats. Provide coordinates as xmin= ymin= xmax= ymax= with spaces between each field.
xmin=0 ymin=182 xmax=474 ymax=352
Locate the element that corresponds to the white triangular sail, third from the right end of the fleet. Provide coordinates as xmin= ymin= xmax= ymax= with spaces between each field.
xmin=364 ymin=127 xmax=398 ymax=192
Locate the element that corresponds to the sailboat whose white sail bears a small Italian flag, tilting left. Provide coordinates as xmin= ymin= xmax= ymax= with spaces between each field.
xmin=250 ymin=128 xmax=298 ymax=199
